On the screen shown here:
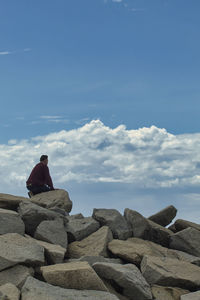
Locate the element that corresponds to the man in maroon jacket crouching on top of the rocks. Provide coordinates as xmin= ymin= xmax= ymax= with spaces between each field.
xmin=26 ymin=155 xmax=54 ymax=197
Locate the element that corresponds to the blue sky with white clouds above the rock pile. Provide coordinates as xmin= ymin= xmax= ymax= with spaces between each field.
xmin=0 ymin=0 xmax=200 ymax=223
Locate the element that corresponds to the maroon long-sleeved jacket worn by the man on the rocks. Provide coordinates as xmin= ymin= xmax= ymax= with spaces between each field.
xmin=26 ymin=162 xmax=54 ymax=189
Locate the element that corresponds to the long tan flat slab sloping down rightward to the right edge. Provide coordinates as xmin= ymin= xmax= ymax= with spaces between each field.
xmin=108 ymin=238 xmax=200 ymax=266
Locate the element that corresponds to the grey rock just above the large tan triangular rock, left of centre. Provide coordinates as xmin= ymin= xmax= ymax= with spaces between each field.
xmin=66 ymin=217 xmax=100 ymax=243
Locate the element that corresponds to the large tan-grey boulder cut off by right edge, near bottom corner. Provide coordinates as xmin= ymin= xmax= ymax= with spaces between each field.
xmin=141 ymin=256 xmax=200 ymax=290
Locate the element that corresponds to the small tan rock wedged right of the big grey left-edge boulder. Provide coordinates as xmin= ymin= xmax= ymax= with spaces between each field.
xmin=35 ymin=240 xmax=66 ymax=265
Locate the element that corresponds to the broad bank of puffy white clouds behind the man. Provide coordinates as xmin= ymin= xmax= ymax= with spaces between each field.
xmin=0 ymin=120 xmax=200 ymax=189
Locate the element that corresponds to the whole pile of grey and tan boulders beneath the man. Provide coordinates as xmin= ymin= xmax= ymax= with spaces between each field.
xmin=0 ymin=190 xmax=200 ymax=300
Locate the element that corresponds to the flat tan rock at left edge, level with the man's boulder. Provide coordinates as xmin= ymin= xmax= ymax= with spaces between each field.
xmin=0 ymin=194 xmax=29 ymax=210
